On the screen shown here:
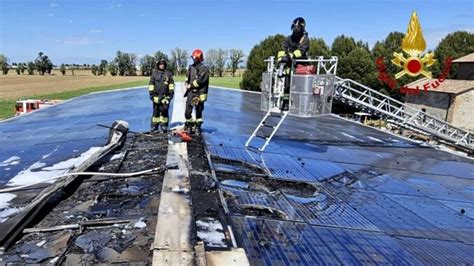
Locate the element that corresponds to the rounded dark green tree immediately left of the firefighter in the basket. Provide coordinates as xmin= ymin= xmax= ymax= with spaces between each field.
xmin=240 ymin=34 xmax=285 ymax=91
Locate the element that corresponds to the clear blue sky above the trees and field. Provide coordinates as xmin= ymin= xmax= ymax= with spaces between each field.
xmin=0 ymin=0 xmax=474 ymax=64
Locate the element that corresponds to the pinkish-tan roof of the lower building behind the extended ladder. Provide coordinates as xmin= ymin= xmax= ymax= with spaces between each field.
xmin=407 ymin=78 xmax=474 ymax=94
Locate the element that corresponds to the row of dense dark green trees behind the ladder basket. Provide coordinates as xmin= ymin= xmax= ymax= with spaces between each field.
xmin=240 ymin=31 xmax=474 ymax=99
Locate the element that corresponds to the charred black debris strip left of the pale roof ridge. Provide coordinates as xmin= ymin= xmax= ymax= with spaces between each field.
xmin=1 ymin=134 xmax=168 ymax=265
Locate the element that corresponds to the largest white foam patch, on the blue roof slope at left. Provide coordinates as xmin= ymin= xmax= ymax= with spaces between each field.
xmin=7 ymin=147 xmax=100 ymax=186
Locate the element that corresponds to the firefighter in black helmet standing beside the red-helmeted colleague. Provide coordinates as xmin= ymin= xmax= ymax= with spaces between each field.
xmin=148 ymin=59 xmax=174 ymax=132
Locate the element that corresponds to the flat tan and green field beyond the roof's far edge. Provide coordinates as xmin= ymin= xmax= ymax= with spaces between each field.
xmin=0 ymin=74 xmax=242 ymax=120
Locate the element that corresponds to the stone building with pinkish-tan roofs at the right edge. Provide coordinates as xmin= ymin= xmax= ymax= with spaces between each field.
xmin=405 ymin=54 xmax=474 ymax=131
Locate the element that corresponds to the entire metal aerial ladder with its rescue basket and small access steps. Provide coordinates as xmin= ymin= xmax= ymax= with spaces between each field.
xmin=245 ymin=56 xmax=474 ymax=153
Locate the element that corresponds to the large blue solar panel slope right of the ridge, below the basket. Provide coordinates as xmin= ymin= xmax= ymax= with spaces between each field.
xmin=200 ymin=90 xmax=474 ymax=265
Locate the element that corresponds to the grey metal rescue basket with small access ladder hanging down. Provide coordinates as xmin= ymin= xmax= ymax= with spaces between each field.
xmin=245 ymin=56 xmax=337 ymax=151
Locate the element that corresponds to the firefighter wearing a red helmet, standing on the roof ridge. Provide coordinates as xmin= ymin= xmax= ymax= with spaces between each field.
xmin=184 ymin=49 xmax=209 ymax=135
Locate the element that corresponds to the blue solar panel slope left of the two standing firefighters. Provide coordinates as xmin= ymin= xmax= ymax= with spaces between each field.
xmin=0 ymin=89 xmax=151 ymax=187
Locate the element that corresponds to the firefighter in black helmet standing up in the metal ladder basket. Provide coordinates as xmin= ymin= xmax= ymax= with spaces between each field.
xmin=277 ymin=17 xmax=309 ymax=111
